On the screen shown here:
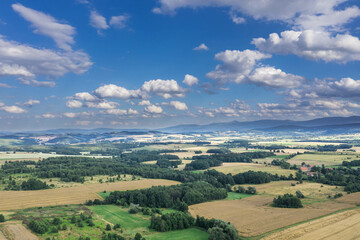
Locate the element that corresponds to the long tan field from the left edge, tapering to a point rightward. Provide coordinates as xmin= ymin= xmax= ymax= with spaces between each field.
xmin=0 ymin=179 xmax=179 ymax=210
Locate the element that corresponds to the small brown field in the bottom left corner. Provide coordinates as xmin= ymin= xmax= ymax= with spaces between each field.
xmin=0 ymin=222 xmax=39 ymax=240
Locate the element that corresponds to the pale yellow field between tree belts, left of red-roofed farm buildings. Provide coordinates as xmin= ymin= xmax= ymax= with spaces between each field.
xmin=211 ymin=163 xmax=296 ymax=176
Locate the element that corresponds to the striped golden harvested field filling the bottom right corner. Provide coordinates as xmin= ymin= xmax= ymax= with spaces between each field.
xmin=263 ymin=209 xmax=360 ymax=240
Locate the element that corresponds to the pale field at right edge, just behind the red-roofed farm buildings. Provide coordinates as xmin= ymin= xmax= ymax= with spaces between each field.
xmin=288 ymin=153 xmax=358 ymax=166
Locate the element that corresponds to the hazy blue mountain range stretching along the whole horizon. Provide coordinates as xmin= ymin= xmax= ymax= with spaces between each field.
xmin=0 ymin=116 xmax=360 ymax=144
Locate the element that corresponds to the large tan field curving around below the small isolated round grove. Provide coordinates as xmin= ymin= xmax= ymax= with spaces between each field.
xmin=189 ymin=195 xmax=355 ymax=239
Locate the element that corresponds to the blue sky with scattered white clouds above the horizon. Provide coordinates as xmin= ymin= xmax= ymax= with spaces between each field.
xmin=0 ymin=0 xmax=360 ymax=131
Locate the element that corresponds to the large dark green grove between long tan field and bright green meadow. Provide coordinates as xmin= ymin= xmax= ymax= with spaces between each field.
xmin=103 ymin=182 xmax=227 ymax=211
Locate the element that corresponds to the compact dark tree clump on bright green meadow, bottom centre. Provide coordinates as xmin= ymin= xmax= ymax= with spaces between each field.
xmin=150 ymin=212 xmax=195 ymax=232
